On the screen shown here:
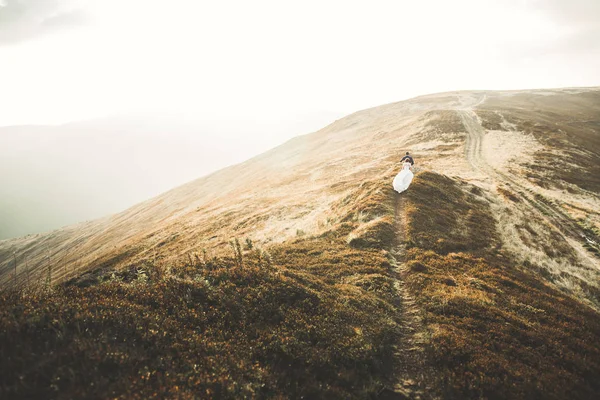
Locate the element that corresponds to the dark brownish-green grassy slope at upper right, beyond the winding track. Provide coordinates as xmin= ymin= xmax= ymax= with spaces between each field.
xmin=477 ymin=91 xmax=600 ymax=193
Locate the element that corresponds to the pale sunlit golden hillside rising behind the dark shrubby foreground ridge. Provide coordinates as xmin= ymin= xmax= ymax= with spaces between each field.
xmin=0 ymin=88 xmax=600 ymax=298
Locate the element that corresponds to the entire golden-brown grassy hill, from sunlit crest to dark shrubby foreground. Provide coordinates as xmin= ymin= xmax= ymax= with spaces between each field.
xmin=0 ymin=88 xmax=600 ymax=399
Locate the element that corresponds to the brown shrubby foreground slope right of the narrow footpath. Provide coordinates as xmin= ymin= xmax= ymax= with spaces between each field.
xmin=406 ymin=173 xmax=600 ymax=399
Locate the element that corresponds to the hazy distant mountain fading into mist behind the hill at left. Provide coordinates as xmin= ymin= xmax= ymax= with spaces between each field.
xmin=0 ymin=113 xmax=335 ymax=239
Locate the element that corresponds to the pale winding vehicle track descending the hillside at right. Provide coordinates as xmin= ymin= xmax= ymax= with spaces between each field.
xmin=457 ymin=104 xmax=600 ymax=251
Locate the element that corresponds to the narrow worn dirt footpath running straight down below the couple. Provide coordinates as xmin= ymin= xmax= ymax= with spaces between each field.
xmin=378 ymin=194 xmax=436 ymax=400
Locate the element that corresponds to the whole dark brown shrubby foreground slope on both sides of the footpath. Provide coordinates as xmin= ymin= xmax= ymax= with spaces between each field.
xmin=0 ymin=172 xmax=600 ymax=399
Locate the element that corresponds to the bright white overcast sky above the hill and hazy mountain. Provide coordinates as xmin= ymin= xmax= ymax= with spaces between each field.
xmin=0 ymin=0 xmax=600 ymax=125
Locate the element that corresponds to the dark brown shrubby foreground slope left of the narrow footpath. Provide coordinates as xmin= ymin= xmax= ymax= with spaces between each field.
xmin=0 ymin=182 xmax=399 ymax=398
